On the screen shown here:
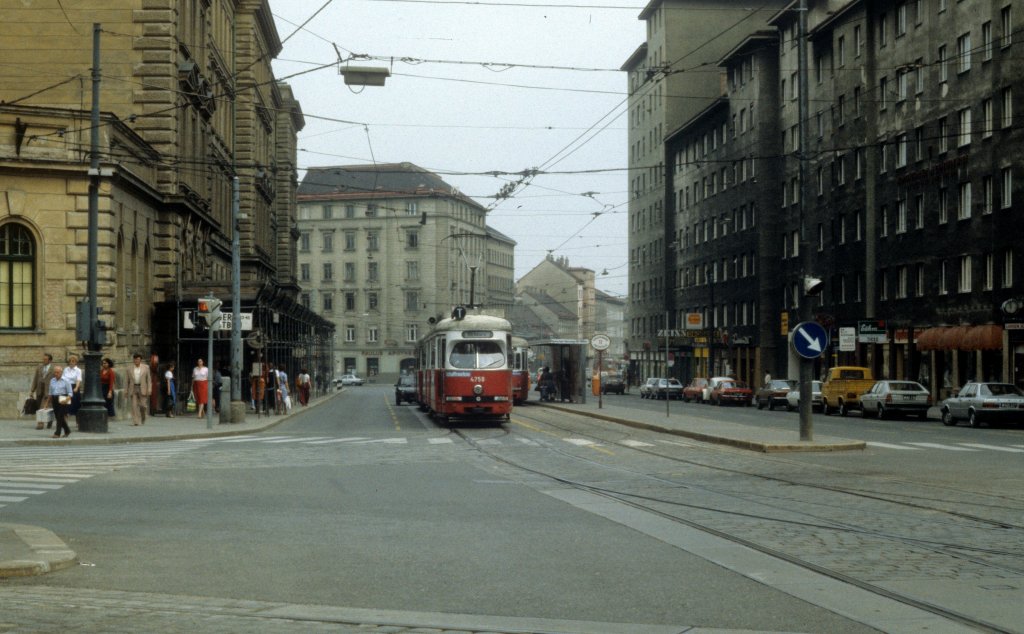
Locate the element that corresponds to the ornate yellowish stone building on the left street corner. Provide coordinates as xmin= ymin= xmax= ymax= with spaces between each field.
xmin=0 ymin=0 xmax=332 ymax=415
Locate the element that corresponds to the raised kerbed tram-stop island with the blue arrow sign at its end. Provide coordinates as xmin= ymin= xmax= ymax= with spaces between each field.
xmin=529 ymin=394 xmax=865 ymax=454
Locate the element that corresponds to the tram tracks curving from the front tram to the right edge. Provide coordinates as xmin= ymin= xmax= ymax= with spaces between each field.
xmin=453 ymin=411 xmax=1024 ymax=632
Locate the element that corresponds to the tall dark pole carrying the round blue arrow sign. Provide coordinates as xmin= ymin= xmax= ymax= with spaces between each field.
xmin=797 ymin=0 xmax=814 ymax=441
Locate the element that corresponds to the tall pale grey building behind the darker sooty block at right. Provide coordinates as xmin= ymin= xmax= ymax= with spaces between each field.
xmin=622 ymin=0 xmax=784 ymax=376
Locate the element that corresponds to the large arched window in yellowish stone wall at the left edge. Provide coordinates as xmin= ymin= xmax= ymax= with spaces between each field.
xmin=0 ymin=222 xmax=36 ymax=329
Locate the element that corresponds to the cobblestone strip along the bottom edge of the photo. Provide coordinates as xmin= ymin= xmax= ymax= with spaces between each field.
xmin=0 ymin=585 xmax=714 ymax=634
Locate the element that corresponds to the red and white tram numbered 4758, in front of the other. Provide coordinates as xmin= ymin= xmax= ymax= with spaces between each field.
xmin=417 ymin=308 xmax=512 ymax=420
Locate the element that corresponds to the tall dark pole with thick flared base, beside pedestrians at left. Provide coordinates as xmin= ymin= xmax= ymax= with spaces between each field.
xmin=77 ymin=24 xmax=108 ymax=433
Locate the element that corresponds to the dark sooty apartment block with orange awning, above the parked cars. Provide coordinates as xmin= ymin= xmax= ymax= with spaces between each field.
xmin=631 ymin=0 xmax=1024 ymax=396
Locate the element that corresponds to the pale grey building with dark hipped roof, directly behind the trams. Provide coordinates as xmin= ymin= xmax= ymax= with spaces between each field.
xmin=298 ymin=163 xmax=515 ymax=376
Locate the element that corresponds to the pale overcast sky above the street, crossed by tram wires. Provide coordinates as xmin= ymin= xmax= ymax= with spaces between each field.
xmin=270 ymin=0 xmax=644 ymax=296
